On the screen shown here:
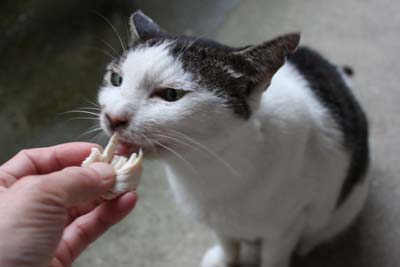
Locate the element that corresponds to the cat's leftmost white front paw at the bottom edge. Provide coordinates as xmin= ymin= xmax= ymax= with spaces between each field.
xmin=201 ymin=235 xmax=240 ymax=267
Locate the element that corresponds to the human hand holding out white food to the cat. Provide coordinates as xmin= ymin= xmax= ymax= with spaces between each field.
xmin=0 ymin=143 xmax=136 ymax=267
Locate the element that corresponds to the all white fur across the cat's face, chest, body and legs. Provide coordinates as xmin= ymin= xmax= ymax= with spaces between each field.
xmin=99 ymin=44 xmax=366 ymax=267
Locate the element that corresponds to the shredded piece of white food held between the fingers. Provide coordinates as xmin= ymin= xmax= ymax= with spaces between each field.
xmin=82 ymin=134 xmax=143 ymax=200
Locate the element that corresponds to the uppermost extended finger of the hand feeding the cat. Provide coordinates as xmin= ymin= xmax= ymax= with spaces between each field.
xmin=0 ymin=142 xmax=98 ymax=187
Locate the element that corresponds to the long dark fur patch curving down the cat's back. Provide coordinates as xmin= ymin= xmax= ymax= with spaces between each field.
xmin=289 ymin=47 xmax=369 ymax=207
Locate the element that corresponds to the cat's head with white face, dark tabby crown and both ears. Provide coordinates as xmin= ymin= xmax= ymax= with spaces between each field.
xmin=98 ymin=11 xmax=300 ymax=157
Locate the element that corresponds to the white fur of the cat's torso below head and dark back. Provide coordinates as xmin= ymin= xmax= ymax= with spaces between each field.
xmin=166 ymin=50 xmax=367 ymax=266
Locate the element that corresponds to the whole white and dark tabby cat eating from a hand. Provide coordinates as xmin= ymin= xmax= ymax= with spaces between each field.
xmin=98 ymin=11 xmax=369 ymax=267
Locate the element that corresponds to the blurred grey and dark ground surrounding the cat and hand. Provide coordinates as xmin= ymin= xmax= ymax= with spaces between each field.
xmin=0 ymin=0 xmax=400 ymax=267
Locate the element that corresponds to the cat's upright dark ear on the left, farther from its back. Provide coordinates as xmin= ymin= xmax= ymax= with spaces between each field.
xmin=129 ymin=10 xmax=168 ymax=42
